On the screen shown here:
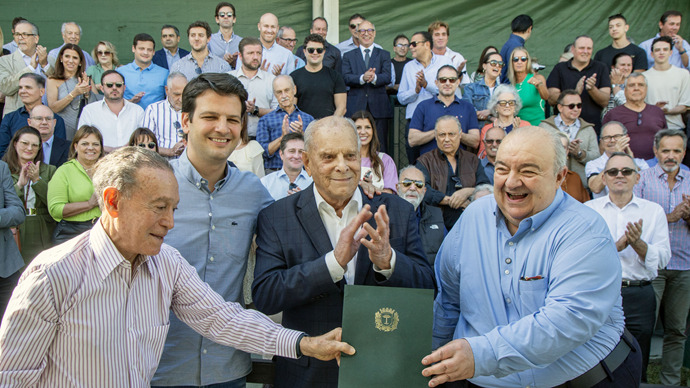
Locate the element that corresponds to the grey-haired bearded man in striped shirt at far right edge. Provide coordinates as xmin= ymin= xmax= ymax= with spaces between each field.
xmin=633 ymin=129 xmax=690 ymax=385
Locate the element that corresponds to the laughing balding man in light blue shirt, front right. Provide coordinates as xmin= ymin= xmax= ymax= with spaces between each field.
xmin=422 ymin=127 xmax=642 ymax=387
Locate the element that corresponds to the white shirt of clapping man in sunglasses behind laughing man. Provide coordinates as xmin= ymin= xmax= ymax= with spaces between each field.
xmin=585 ymin=195 xmax=671 ymax=280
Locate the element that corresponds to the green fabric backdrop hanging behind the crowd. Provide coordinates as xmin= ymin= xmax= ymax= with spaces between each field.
xmin=0 ymin=0 xmax=690 ymax=77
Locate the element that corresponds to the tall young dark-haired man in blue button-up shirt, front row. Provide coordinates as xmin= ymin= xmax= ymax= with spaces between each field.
xmin=151 ymin=73 xmax=273 ymax=388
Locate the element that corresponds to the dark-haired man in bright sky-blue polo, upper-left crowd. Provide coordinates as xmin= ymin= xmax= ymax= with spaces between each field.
xmin=117 ymin=33 xmax=168 ymax=109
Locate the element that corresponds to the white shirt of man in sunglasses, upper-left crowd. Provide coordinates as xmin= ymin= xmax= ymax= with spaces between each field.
xmin=78 ymin=100 xmax=144 ymax=147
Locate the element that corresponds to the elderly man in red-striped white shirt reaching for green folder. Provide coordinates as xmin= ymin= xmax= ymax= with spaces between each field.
xmin=0 ymin=147 xmax=354 ymax=387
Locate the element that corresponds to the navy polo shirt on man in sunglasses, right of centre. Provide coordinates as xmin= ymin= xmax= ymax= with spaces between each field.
xmin=410 ymin=95 xmax=479 ymax=155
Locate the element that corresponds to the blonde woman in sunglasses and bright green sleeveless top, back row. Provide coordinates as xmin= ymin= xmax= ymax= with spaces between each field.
xmin=508 ymin=47 xmax=549 ymax=126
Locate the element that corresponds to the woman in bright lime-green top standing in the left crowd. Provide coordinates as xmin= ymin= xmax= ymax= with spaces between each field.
xmin=48 ymin=125 xmax=104 ymax=244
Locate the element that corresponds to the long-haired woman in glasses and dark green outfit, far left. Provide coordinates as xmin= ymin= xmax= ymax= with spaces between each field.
xmin=2 ymin=126 xmax=55 ymax=264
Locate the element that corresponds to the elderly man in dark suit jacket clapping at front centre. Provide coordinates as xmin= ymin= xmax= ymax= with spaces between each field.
xmin=252 ymin=116 xmax=434 ymax=388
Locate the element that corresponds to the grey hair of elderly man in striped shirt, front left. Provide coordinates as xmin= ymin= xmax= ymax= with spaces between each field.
xmin=93 ymin=147 xmax=173 ymax=210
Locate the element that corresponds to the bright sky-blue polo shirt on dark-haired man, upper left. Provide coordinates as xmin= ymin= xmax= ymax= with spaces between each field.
xmin=117 ymin=62 xmax=168 ymax=109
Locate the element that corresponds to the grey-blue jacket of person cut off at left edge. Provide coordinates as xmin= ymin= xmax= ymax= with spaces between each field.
xmin=0 ymin=161 xmax=26 ymax=278
